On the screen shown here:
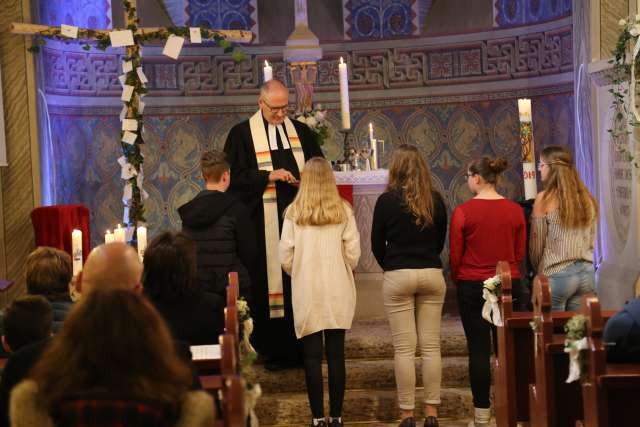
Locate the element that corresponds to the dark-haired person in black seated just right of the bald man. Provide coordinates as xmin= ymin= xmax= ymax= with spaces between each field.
xmin=142 ymin=231 xmax=226 ymax=345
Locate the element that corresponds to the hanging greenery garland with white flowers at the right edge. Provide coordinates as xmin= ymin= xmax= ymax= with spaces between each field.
xmin=607 ymin=15 xmax=640 ymax=168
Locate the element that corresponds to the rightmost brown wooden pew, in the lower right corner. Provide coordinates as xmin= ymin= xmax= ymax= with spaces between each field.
xmin=576 ymin=298 xmax=640 ymax=427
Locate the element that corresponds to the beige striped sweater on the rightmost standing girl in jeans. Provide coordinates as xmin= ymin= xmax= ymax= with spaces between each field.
xmin=529 ymin=209 xmax=596 ymax=276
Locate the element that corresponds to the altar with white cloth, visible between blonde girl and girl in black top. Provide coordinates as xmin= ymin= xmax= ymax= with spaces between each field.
xmin=335 ymin=169 xmax=389 ymax=319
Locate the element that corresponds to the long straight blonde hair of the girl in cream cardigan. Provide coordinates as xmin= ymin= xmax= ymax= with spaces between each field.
xmin=285 ymin=157 xmax=347 ymax=225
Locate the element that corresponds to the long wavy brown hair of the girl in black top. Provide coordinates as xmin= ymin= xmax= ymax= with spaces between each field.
xmin=387 ymin=144 xmax=433 ymax=227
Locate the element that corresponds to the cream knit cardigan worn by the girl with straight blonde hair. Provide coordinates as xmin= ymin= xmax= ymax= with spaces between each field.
xmin=280 ymin=207 xmax=360 ymax=338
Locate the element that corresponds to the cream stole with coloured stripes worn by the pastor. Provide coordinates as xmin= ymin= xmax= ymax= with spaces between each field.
xmin=247 ymin=111 xmax=304 ymax=319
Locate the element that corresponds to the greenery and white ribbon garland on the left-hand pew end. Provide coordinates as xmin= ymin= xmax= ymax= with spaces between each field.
xmin=236 ymin=298 xmax=262 ymax=427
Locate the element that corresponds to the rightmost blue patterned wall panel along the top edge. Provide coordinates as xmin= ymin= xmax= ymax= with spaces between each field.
xmin=494 ymin=0 xmax=572 ymax=27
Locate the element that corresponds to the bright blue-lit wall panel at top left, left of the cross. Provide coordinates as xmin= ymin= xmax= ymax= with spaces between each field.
xmin=38 ymin=0 xmax=113 ymax=28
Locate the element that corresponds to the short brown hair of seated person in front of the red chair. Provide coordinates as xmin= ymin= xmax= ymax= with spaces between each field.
xmin=26 ymin=246 xmax=73 ymax=301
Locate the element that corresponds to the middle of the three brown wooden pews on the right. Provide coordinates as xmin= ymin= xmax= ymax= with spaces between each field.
xmin=529 ymin=275 xmax=582 ymax=427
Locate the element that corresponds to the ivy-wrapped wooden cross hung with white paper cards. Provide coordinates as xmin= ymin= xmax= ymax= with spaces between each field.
xmin=28 ymin=0 xmax=246 ymax=227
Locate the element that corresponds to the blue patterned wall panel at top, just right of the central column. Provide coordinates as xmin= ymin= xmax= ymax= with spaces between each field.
xmin=343 ymin=0 xmax=420 ymax=40
